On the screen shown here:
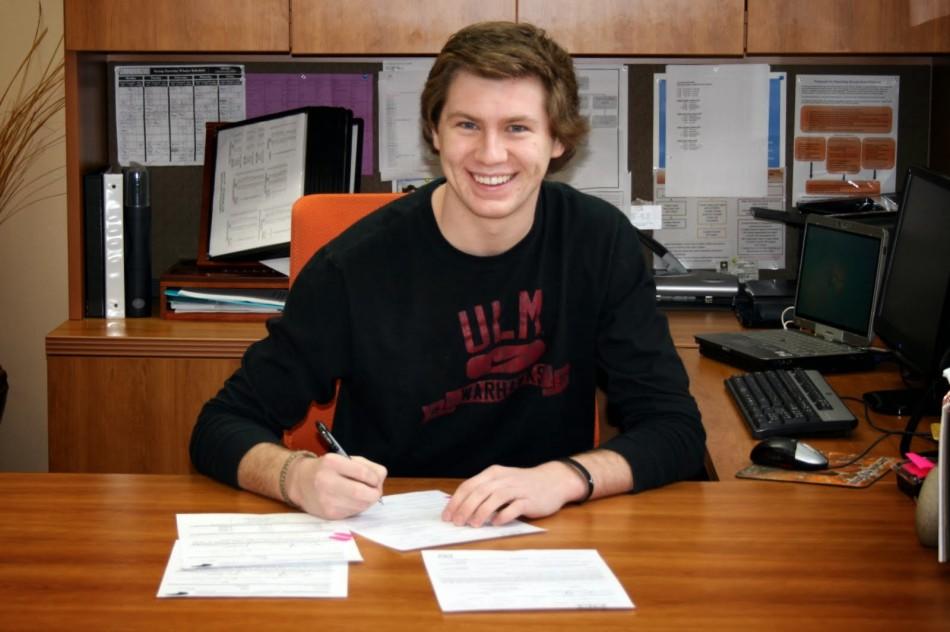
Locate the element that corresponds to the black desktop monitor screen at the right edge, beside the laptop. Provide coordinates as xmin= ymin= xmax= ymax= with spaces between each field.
xmin=874 ymin=168 xmax=950 ymax=380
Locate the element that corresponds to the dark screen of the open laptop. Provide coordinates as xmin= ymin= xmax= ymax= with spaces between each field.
xmin=795 ymin=216 xmax=887 ymax=346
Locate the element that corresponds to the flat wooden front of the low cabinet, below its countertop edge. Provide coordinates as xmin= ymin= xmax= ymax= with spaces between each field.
xmin=47 ymin=356 xmax=241 ymax=474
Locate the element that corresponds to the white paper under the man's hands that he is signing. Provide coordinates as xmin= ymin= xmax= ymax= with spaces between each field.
xmin=345 ymin=490 xmax=545 ymax=551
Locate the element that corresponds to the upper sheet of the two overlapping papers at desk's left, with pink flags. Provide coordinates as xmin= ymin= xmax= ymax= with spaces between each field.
xmin=177 ymin=513 xmax=363 ymax=568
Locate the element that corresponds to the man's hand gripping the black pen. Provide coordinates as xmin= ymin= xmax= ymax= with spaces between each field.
xmin=287 ymin=453 xmax=387 ymax=520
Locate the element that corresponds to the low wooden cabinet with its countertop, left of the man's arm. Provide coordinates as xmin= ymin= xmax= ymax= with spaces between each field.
xmin=46 ymin=318 xmax=264 ymax=474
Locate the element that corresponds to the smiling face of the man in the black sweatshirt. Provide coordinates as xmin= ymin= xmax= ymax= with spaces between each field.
xmin=433 ymin=72 xmax=564 ymax=226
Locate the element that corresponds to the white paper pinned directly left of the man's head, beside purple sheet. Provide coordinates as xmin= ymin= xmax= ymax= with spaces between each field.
xmin=377 ymin=58 xmax=441 ymax=180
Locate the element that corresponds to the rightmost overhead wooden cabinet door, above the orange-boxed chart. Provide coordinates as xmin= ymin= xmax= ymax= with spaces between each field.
xmin=748 ymin=0 xmax=950 ymax=54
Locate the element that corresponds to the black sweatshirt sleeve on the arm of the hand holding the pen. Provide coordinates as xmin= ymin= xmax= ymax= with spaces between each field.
xmin=190 ymin=251 xmax=350 ymax=487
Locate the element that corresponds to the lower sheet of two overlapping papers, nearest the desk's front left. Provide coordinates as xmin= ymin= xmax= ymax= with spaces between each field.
xmin=157 ymin=540 xmax=349 ymax=597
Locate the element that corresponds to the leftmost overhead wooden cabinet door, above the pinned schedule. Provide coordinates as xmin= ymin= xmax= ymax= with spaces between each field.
xmin=63 ymin=0 xmax=290 ymax=52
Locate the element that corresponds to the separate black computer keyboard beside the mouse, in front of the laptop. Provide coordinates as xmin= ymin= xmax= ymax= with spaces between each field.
xmin=726 ymin=369 xmax=858 ymax=439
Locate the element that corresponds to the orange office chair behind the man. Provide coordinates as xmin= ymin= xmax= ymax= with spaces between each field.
xmin=284 ymin=193 xmax=403 ymax=454
